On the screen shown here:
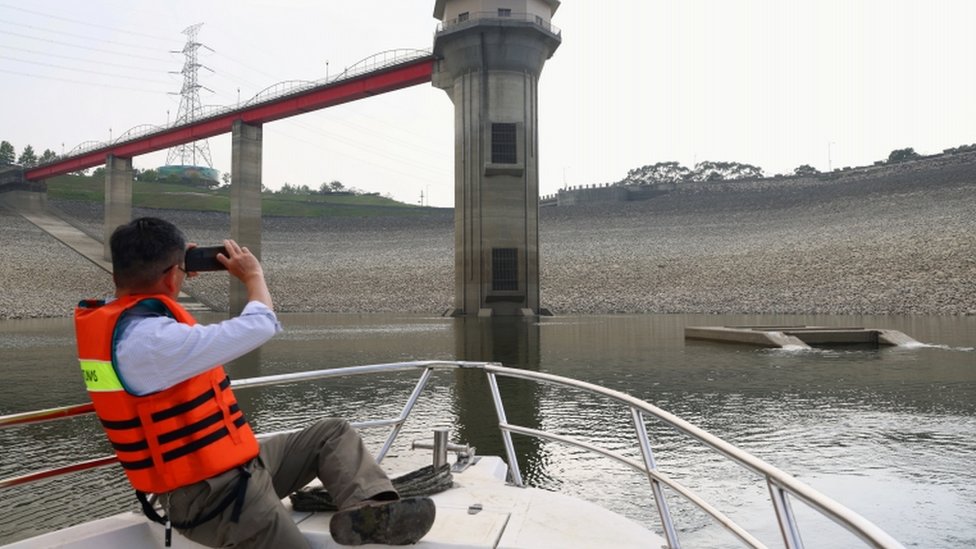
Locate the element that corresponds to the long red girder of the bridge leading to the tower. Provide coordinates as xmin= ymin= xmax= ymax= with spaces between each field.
xmin=24 ymin=57 xmax=435 ymax=181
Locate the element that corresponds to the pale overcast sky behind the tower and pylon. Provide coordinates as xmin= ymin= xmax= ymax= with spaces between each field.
xmin=0 ymin=0 xmax=976 ymax=206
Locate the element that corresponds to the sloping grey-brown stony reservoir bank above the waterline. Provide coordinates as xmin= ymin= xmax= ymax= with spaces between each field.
xmin=0 ymin=160 xmax=976 ymax=319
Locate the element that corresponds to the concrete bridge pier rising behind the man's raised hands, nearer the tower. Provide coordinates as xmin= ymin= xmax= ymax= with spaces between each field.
xmin=229 ymin=120 xmax=263 ymax=316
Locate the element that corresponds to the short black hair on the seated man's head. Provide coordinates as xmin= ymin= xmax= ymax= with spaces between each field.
xmin=109 ymin=217 xmax=186 ymax=290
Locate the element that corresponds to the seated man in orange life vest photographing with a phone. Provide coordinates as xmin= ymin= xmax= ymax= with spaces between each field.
xmin=75 ymin=217 xmax=435 ymax=548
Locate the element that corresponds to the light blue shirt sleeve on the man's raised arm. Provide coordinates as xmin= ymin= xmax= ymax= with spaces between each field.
xmin=115 ymin=301 xmax=281 ymax=395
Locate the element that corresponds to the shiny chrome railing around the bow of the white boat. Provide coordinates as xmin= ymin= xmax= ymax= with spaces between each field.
xmin=0 ymin=361 xmax=903 ymax=549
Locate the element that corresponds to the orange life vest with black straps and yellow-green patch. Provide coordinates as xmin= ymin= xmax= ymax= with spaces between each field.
xmin=75 ymin=295 xmax=259 ymax=494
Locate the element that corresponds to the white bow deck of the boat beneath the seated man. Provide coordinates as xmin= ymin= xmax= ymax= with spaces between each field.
xmin=7 ymin=456 xmax=667 ymax=549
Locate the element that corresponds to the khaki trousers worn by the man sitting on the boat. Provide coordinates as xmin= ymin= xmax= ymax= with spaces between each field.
xmin=160 ymin=419 xmax=393 ymax=549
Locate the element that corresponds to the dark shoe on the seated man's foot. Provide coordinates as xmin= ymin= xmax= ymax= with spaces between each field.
xmin=329 ymin=498 xmax=437 ymax=545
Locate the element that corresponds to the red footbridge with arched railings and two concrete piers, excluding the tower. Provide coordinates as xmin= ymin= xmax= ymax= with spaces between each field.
xmin=11 ymin=49 xmax=435 ymax=311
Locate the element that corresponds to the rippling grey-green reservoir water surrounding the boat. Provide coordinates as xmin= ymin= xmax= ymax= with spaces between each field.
xmin=0 ymin=315 xmax=976 ymax=548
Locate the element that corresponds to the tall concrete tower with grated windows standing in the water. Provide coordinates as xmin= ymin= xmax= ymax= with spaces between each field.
xmin=432 ymin=0 xmax=562 ymax=316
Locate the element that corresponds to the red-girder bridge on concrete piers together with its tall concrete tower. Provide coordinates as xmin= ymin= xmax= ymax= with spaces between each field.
xmin=7 ymin=0 xmax=562 ymax=316
